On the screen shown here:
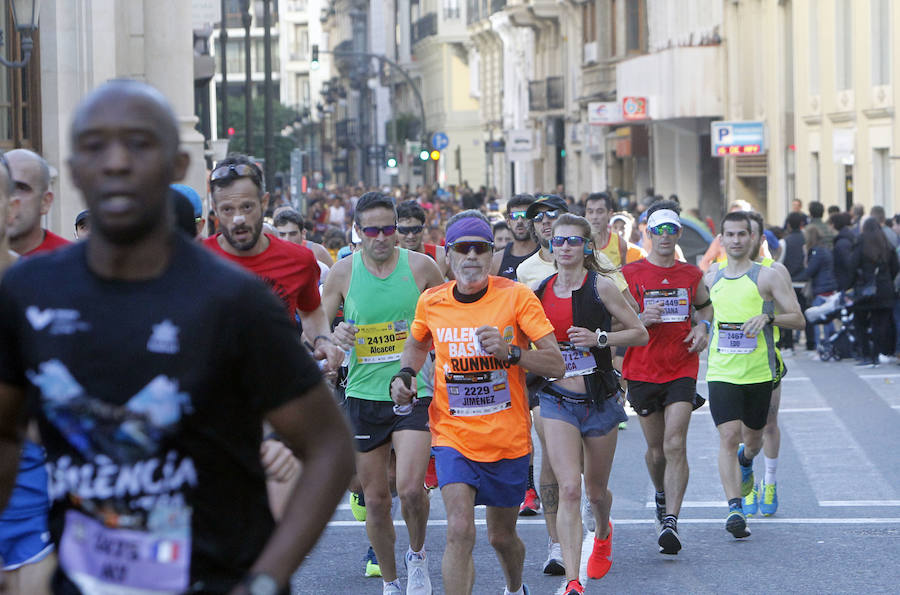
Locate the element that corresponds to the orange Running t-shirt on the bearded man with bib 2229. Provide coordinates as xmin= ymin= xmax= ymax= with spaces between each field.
xmin=412 ymin=276 xmax=553 ymax=463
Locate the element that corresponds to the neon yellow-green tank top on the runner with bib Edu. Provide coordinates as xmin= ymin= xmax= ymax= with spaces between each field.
xmin=706 ymin=263 xmax=776 ymax=384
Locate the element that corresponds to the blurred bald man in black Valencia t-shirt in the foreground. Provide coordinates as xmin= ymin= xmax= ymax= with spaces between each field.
xmin=0 ymin=81 xmax=353 ymax=593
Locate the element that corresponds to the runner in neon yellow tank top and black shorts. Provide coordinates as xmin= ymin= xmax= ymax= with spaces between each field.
xmin=705 ymin=211 xmax=806 ymax=538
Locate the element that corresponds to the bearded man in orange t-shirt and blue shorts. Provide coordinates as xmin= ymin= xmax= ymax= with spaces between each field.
xmin=390 ymin=210 xmax=565 ymax=595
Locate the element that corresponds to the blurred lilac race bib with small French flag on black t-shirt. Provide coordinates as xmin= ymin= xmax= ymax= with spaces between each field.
xmin=59 ymin=508 xmax=191 ymax=595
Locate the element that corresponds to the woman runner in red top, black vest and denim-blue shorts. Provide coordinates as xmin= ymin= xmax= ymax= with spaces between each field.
xmin=535 ymin=213 xmax=647 ymax=595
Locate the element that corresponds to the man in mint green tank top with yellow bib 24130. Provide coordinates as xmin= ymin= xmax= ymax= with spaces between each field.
xmin=322 ymin=192 xmax=444 ymax=594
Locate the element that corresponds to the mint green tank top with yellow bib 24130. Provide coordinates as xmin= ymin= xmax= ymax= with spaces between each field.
xmin=344 ymin=248 xmax=430 ymax=401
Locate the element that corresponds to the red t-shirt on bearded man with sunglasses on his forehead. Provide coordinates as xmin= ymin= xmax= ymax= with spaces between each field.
xmin=203 ymin=234 xmax=322 ymax=316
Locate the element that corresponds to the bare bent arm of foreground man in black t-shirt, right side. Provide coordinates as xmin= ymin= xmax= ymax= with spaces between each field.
xmin=250 ymin=382 xmax=353 ymax=588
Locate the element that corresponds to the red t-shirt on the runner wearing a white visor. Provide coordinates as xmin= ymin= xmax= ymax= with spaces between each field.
xmin=622 ymin=259 xmax=703 ymax=384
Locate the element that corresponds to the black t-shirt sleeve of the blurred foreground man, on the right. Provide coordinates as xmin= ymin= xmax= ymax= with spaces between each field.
xmin=235 ymin=281 xmax=322 ymax=413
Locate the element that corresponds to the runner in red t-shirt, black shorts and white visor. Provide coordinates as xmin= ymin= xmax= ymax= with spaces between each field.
xmin=622 ymin=200 xmax=712 ymax=554
